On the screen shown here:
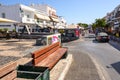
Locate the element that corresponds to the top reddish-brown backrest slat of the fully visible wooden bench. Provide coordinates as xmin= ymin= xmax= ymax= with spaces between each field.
xmin=32 ymin=42 xmax=60 ymax=58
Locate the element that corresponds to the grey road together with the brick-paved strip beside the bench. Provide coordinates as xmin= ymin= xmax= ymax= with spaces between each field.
xmin=65 ymin=35 xmax=120 ymax=80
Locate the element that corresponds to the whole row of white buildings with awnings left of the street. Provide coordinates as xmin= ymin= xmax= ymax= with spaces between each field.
xmin=0 ymin=4 xmax=66 ymax=32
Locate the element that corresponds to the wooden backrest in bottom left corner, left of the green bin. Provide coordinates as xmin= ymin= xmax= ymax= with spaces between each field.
xmin=0 ymin=62 xmax=17 ymax=80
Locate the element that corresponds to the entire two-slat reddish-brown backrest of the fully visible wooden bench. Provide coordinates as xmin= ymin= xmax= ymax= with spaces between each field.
xmin=32 ymin=42 xmax=60 ymax=65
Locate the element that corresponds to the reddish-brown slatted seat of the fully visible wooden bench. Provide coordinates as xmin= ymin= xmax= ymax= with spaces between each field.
xmin=36 ymin=48 xmax=67 ymax=69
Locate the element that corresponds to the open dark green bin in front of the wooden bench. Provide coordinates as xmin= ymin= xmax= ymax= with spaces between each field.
xmin=17 ymin=65 xmax=50 ymax=80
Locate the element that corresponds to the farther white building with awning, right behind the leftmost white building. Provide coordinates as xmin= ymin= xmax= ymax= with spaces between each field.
xmin=31 ymin=4 xmax=59 ymax=28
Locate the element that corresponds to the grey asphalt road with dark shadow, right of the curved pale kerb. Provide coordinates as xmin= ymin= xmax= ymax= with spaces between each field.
xmin=84 ymin=38 xmax=120 ymax=80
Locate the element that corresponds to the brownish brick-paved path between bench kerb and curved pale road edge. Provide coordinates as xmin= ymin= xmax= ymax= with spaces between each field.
xmin=64 ymin=39 xmax=102 ymax=80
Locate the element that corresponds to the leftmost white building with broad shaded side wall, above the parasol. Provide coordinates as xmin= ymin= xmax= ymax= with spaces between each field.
xmin=0 ymin=4 xmax=35 ymax=30
